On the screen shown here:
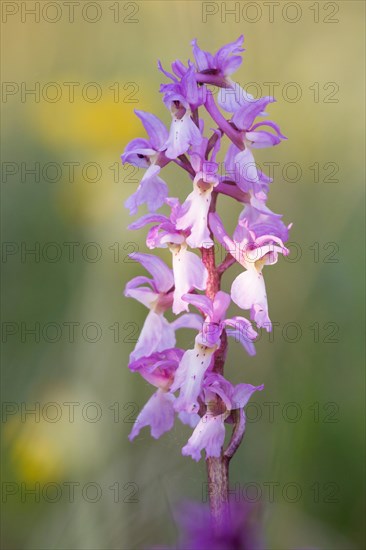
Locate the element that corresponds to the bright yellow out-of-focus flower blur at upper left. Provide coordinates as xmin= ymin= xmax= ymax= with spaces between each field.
xmin=30 ymin=77 xmax=155 ymax=156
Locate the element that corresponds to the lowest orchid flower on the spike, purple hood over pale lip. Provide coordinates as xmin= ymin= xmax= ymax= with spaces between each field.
xmin=182 ymin=373 xmax=264 ymax=461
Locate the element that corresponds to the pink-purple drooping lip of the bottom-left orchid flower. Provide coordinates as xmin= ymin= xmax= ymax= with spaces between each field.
xmin=129 ymin=389 xmax=175 ymax=441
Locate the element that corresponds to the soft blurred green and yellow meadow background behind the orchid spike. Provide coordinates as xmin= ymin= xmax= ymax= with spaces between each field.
xmin=1 ymin=0 xmax=365 ymax=550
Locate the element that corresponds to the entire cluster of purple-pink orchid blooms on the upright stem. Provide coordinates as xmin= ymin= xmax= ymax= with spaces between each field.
xmin=122 ymin=36 xmax=290 ymax=460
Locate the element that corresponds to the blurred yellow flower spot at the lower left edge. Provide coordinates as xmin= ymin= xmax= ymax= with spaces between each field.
xmin=4 ymin=386 xmax=102 ymax=483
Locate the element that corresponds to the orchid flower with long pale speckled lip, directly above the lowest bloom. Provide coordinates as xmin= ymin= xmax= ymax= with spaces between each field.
xmin=171 ymin=291 xmax=257 ymax=413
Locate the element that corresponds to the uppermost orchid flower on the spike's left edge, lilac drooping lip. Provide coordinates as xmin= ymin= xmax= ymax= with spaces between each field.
xmin=122 ymin=110 xmax=168 ymax=215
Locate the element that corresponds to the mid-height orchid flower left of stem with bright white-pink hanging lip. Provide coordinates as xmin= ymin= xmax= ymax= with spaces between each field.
xmin=129 ymin=198 xmax=208 ymax=315
